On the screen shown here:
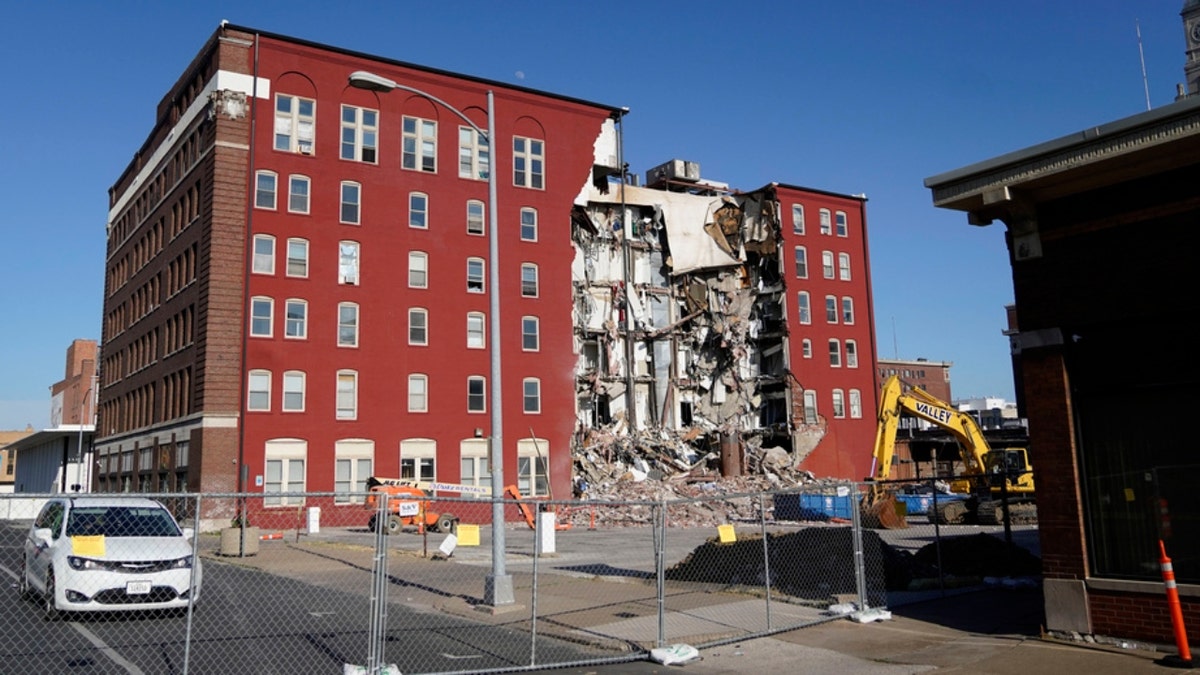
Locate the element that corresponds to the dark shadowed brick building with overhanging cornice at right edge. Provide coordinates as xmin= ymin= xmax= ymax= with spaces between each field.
xmin=925 ymin=0 xmax=1200 ymax=645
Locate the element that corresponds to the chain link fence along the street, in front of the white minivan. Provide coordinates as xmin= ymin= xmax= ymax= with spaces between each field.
xmin=0 ymin=484 xmax=1041 ymax=675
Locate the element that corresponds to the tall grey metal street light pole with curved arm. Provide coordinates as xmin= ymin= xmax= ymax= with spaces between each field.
xmin=350 ymin=71 xmax=514 ymax=608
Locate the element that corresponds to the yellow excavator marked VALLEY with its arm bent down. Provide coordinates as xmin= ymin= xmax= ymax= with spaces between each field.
xmin=862 ymin=375 xmax=1037 ymax=530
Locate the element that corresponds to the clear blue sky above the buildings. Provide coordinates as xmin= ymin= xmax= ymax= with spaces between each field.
xmin=0 ymin=0 xmax=1184 ymax=429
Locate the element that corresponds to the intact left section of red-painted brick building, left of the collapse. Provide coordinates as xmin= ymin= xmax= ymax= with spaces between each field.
xmin=96 ymin=18 xmax=620 ymax=512
